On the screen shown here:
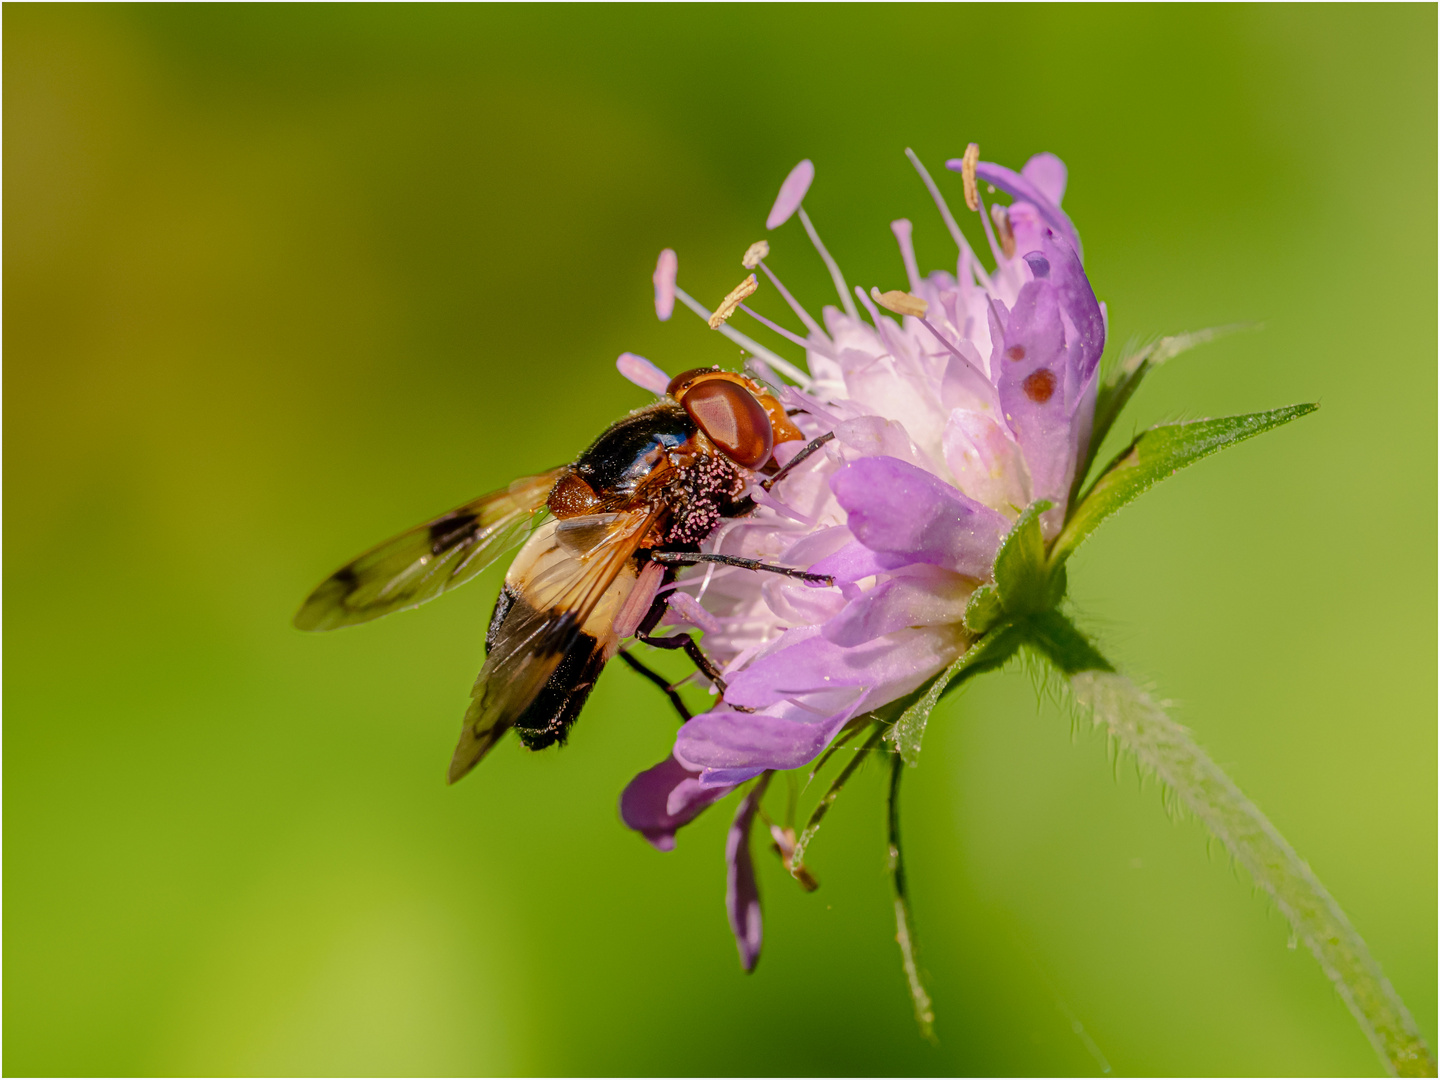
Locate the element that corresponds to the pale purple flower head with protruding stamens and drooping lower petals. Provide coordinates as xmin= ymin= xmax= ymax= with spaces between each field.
xmin=607 ymin=151 xmax=1104 ymax=969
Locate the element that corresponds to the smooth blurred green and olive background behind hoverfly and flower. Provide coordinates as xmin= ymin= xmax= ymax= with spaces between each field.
xmin=4 ymin=4 xmax=1437 ymax=1074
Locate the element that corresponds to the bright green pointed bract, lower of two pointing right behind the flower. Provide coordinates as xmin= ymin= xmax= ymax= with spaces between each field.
xmin=1048 ymin=403 xmax=1320 ymax=570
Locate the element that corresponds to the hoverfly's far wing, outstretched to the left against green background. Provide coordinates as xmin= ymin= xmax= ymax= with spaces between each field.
xmin=295 ymin=469 xmax=563 ymax=631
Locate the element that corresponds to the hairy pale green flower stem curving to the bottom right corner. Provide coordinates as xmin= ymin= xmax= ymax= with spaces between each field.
xmin=1030 ymin=612 xmax=1436 ymax=1076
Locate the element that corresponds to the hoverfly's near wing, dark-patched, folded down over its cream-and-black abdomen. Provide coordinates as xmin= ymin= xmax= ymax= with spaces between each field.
xmin=449 ymin=507 xmax=662 ymax=783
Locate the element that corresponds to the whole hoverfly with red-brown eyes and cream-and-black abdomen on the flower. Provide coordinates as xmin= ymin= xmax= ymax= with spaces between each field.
xmin=295 ymin=367 xmax=831 ymax=783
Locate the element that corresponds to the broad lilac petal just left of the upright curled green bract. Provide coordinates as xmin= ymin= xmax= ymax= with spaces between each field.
xmin=831 ymin=458 xmax=1009 ymax=577
